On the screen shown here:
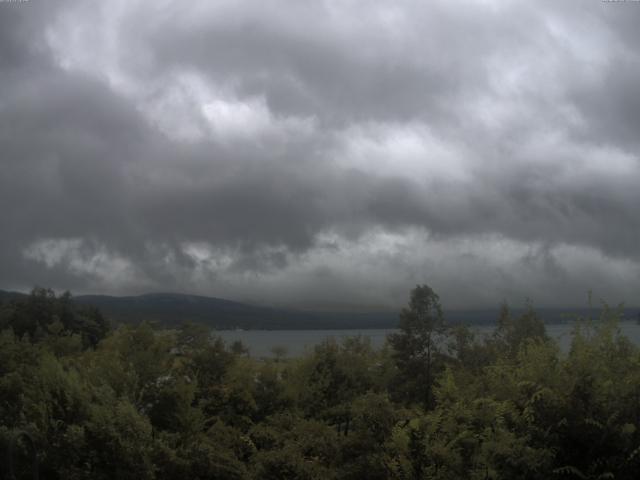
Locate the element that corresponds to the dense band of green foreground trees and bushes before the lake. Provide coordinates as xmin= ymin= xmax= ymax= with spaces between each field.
xmin=0 ymin=285 xmax=640 ymax=480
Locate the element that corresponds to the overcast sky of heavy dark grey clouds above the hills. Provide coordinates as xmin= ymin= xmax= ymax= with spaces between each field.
xmin=0 ymin=0 xmax=640 ymax=308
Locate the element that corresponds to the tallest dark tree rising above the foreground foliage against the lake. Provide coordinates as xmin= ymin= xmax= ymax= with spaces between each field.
xmin=389 ymin=285 xmax=447 ymax=409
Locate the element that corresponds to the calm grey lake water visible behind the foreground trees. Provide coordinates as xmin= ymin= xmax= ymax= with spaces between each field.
xmin=215 ymin=322 xmax=640 ymax=357
